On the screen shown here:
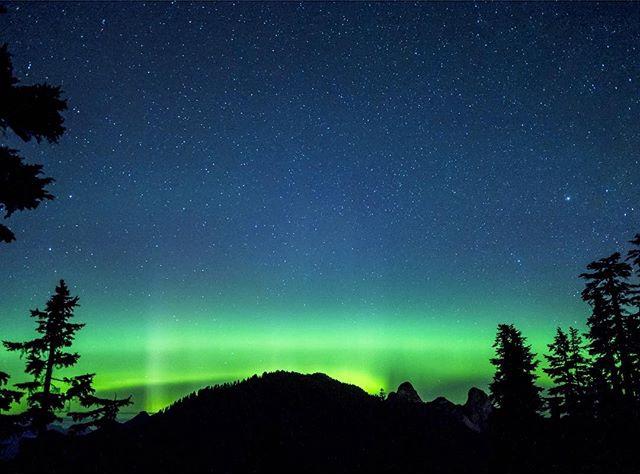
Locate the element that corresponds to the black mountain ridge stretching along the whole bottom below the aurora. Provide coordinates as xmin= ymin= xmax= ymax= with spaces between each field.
xmin=5 ymin=371 xmax=639 ymax=474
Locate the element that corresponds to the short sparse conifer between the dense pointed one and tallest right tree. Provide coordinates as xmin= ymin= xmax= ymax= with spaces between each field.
xmin=543 ymin=327 xmax=588 ymax=416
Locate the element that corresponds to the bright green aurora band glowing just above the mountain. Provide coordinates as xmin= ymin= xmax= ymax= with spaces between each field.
xmin=0 ymin=294 xmax=576 ymax=411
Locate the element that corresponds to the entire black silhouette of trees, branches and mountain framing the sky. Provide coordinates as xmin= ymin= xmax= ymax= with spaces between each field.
xmin=0 ymin=3 xmax=640 ymax=474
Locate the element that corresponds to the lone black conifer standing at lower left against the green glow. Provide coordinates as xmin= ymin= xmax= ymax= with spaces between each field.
xmin=3 ymin=280 xmax=93 ymax=431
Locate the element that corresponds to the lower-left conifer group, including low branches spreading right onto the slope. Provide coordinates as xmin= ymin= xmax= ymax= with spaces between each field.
xmin=0 ymin=280 xmax=131 ymax=439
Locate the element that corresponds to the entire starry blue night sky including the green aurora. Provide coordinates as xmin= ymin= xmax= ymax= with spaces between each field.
xmin=0 ymin=2 xmax=640 ymax=410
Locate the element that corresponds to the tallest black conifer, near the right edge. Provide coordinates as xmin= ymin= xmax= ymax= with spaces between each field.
xmin=580 ymin=252 xmax=639 ymax=403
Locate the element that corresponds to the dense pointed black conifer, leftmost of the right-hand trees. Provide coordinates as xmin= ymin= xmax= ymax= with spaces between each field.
xmin=489 ymin=324 xmax=542 ymax=422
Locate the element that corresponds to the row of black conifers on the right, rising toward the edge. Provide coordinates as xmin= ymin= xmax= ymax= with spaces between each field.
xmin=490 ymin=234 xmax=640 ymax=419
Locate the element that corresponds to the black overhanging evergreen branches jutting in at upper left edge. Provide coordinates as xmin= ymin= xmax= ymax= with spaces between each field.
xmin=0 ymin=10 xmax=67 ymax=242
